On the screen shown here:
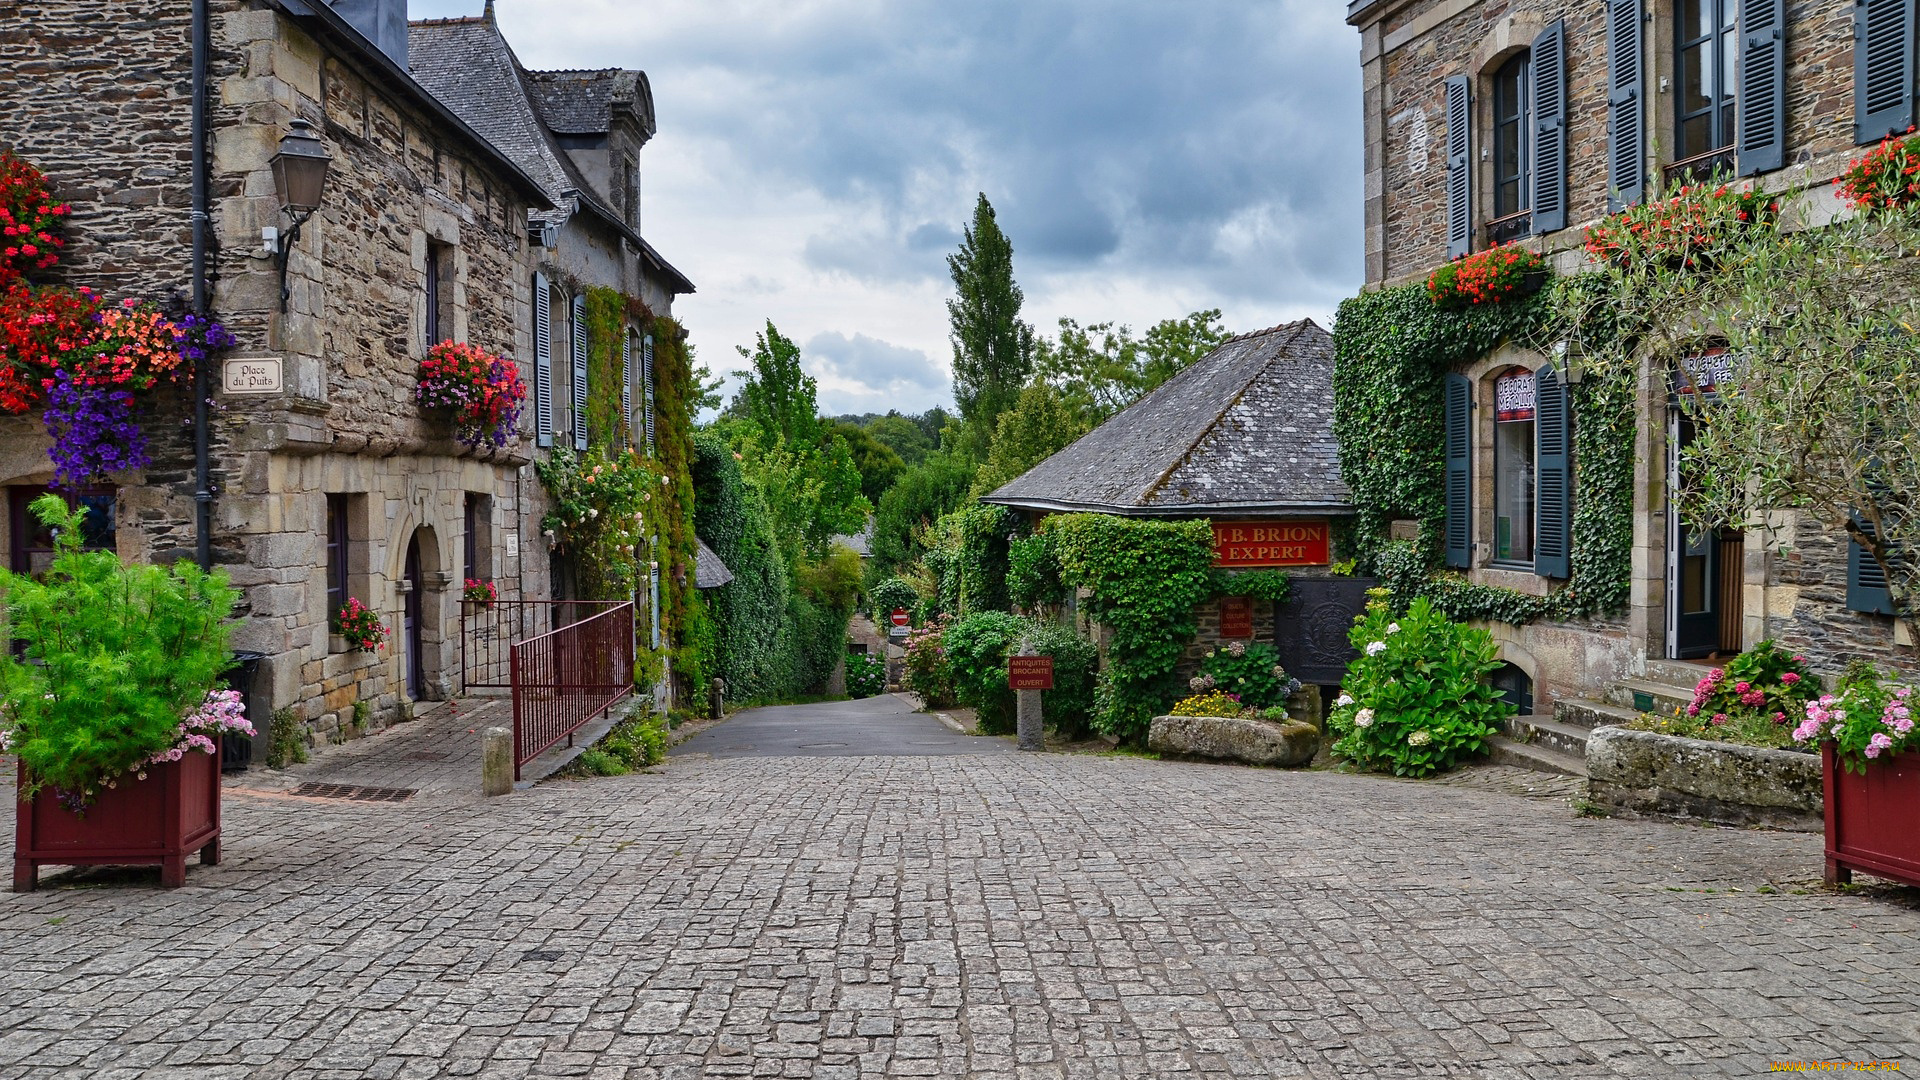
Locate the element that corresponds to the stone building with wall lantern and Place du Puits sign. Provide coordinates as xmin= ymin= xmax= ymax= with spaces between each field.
xmin=0 ymin=0 xmax=684 ymax=736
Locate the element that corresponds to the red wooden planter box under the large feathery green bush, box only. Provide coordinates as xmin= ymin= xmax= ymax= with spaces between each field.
xmin=13 ymin=751 xmax=221 ymax=892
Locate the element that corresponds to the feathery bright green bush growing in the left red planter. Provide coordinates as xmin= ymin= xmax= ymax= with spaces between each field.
xmin=0 ymin=494 xmax=238 ymax=803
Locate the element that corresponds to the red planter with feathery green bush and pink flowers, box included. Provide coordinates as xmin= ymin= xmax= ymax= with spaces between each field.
xmin=0 ymin=496 xmax=253 ymax=892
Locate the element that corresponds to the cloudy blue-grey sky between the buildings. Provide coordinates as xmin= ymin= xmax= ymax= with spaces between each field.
xmin=411 ymin=0 xmax=1361 ymax=413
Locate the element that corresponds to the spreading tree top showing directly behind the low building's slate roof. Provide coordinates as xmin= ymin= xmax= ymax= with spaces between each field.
xmin=1035 ymin=307 xmax=1231 ymax=427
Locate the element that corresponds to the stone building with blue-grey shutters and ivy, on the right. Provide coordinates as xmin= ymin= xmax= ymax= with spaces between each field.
xmin=1348 ymin=0 xmax=1914 ymax=713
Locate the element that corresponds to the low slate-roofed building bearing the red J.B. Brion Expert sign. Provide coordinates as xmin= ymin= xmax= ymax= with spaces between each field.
xmin=981 ymin=319 xmax=1371 ymax=717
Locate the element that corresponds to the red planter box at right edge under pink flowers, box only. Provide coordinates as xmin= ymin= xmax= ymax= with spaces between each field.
xmin=1820 ymin=742 xmax=1920 ymax=886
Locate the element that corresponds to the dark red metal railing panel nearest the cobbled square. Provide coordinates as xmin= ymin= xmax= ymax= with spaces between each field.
xmin=509 ymin=603 xmax=634 ymax=780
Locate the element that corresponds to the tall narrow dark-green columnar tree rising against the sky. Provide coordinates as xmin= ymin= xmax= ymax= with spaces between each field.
xmin=947 ymin=194 xmax=1035 ymax=450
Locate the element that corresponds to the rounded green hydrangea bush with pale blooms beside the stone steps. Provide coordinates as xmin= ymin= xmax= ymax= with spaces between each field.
xmin=1329 ymin=588 xmax=1513 ymax=776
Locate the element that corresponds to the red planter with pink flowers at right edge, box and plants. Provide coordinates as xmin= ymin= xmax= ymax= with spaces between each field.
xmin=1793 ymin=663 xmax=1920 ymax=886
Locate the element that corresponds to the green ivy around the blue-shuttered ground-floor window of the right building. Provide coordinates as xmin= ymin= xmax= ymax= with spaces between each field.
xmin=1334 ymin=279 xmax=1634 ymax=623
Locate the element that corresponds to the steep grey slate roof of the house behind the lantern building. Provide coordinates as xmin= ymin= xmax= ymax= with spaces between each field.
xmin=407 ymin=15 xmax=693 ymax=292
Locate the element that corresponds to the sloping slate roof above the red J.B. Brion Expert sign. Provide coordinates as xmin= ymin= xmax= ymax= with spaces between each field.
xmin=983 ymin=319 xmax=1352 ymax=517
